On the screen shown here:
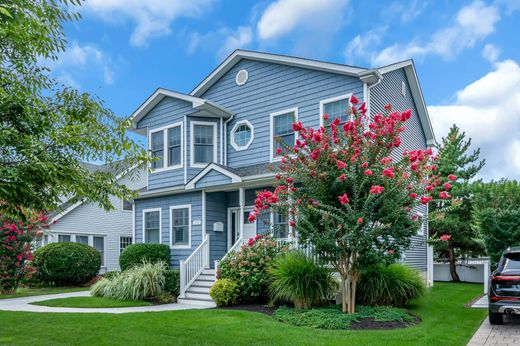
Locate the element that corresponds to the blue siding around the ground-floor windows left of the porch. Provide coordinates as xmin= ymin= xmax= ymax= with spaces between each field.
xmin=135 ymin=192 xmax=202 ymax=268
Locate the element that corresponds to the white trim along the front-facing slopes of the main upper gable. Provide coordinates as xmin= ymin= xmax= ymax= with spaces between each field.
xmin=190 ymin=49 xmax=366 ymax=96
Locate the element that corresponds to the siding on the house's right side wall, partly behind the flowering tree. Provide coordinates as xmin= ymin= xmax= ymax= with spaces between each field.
xmin=370 ymin=69 xmax=428 ymax=271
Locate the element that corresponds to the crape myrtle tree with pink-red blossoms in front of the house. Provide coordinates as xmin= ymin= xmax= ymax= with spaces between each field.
xmin=249 ymin=96 xmax=456 ymax=313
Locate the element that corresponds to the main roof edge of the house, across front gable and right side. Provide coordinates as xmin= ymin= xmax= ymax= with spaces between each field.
xmin=190 ymin=49 xmax=435 ymax=145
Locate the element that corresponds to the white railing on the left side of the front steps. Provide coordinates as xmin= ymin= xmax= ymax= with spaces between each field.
xmin=179 ymin=234 xmax=210 ymax=298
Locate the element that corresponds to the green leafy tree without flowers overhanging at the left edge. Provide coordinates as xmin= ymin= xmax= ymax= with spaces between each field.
xmin=0 ymin=0 xmax=147 ymax=222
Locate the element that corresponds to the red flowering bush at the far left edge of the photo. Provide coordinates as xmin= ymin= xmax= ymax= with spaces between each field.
xmin=0 ymin=214 xmax=47 ymax=293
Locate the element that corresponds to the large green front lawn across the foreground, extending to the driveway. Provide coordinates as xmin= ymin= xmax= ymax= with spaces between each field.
xmin=0 ymin=283 xmax=487 ymax=346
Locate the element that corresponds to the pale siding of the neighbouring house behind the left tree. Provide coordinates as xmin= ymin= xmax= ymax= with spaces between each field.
xmin=49 ymin=169 xmax=146 ymax=271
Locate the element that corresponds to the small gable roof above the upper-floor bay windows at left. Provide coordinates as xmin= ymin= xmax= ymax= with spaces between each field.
xmin=130 ymin=88 xmax=233 ymax=129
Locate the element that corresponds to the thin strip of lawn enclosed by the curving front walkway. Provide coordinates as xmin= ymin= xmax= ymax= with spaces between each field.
xmin=31 ymin=297 xmax=151 ymax=308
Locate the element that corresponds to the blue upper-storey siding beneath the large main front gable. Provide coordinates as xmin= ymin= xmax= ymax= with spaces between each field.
xmin=202 ymin=59 xmax=363 ymax=167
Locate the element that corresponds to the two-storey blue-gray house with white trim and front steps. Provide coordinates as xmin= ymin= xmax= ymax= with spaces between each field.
xmin=128 ymin=50 xmax=435 ymax=304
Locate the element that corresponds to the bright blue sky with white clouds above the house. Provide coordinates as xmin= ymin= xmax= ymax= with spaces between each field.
xmin=53 ymin=0 xmax=520 ymax=179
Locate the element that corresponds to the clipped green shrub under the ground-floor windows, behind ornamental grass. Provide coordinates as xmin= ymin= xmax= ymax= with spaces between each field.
xmin=119 ymin=244 xmax=170 ymax=270
